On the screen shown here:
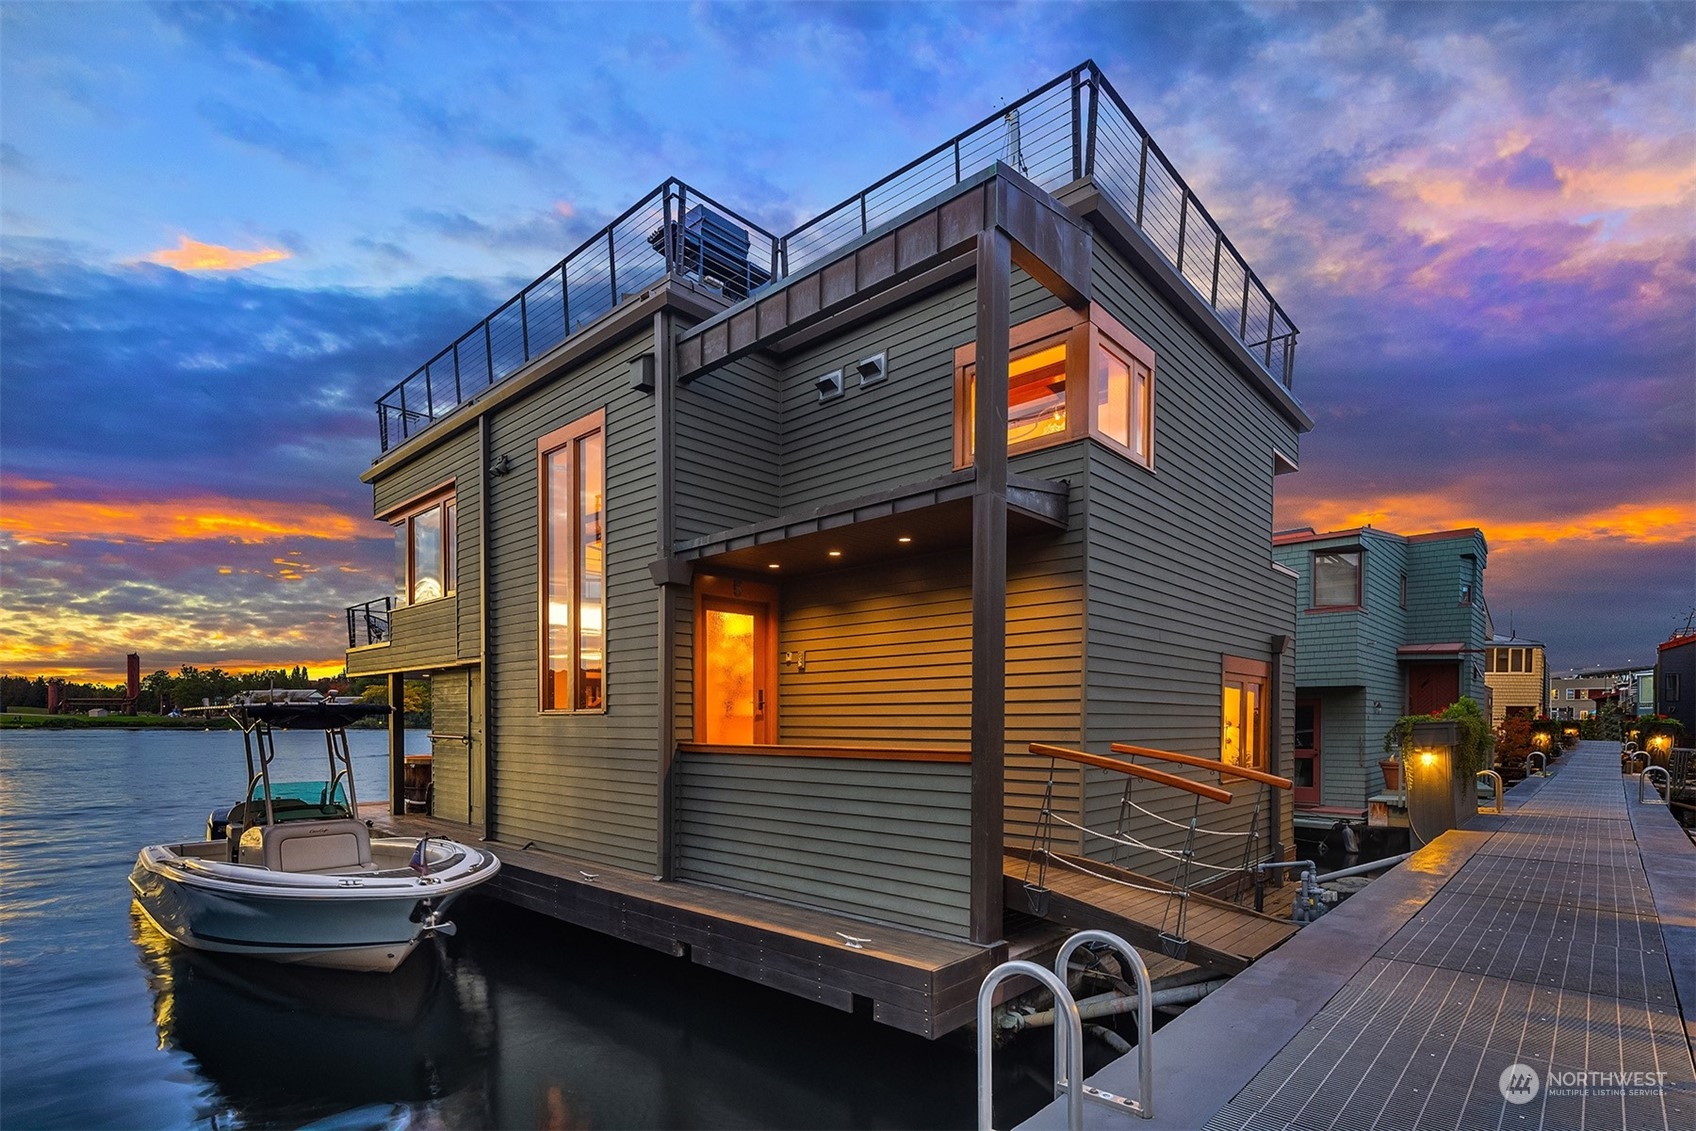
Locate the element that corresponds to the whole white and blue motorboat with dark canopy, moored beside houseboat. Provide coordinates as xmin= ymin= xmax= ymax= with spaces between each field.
xmin=129 ymin=692 xmax=500 ymax=973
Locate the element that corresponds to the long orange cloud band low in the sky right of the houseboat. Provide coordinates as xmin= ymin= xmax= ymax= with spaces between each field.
xmin=1279 ymin=493 xmax=1696 ymax=548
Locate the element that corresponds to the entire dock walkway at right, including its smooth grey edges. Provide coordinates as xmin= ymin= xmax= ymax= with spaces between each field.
xmin=1024 ymin=743 xmax=1696 ymax=1131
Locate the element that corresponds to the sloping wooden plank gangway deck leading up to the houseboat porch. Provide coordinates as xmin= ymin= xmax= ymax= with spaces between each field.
xmin=1004 ymin=853 xmax=1301 ymax=977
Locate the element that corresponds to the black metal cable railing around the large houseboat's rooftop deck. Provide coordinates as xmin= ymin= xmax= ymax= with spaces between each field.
xmin=377 ymin=61 xmax=1297 ymax=451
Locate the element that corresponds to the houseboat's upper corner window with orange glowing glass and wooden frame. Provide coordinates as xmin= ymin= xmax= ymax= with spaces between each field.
xmin=955 ymin=304 xmax=1155 ymax=468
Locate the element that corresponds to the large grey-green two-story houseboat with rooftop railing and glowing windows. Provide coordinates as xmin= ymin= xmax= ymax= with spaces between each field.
xmin=348 ymin=64 xmax=1311 ymax=1034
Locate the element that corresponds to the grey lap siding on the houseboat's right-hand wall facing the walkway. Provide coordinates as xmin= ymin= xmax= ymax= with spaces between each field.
xmin=1074 ymin=241 xmax=1297 ymax=882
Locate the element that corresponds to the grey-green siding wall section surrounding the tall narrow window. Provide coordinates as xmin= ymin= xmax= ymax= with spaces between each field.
xmin=487 ymin=334 xmax=660 ymax=870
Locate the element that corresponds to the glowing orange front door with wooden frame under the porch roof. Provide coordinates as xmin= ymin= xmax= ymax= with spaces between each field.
xmin=695 ymin=578 xmax=777 ymax=746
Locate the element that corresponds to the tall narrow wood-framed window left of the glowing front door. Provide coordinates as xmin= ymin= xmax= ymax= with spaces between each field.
xmin=538 ymin=412 xmax=607 ymax=710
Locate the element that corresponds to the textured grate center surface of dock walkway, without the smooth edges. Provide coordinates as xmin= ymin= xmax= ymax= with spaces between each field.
xmin=1208 ymin=743 xmax=1696 ymax=1131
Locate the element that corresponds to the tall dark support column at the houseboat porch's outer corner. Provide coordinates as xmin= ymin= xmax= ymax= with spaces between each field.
xmin=970 ymin=226 xmax=1013 ymax=943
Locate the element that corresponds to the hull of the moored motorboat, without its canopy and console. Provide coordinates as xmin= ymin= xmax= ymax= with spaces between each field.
xmin=129 ymin=839 xmax=500 ymax=973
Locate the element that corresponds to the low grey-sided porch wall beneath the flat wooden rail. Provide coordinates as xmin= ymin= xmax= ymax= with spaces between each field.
xmin=677 ymin=753 xmax=972 ymax=938
